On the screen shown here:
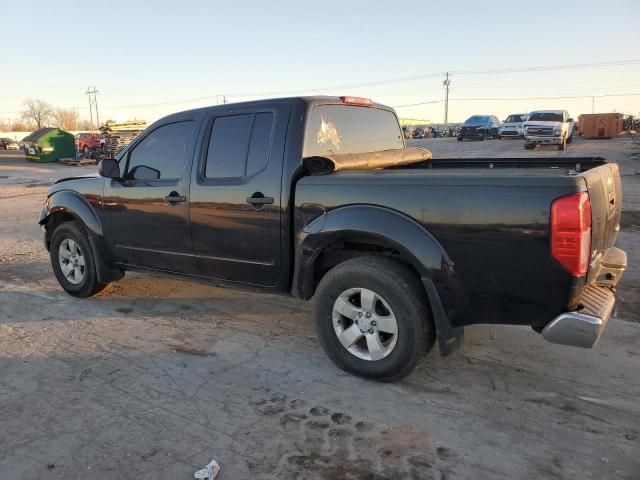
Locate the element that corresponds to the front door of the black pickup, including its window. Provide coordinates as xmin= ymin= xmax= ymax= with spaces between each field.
xmin=103 ymin=119 xmax=198 ymax=274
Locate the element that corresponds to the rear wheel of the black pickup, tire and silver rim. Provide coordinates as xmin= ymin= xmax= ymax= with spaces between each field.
xmin=314 ymin=257 xmax=435 ymax=382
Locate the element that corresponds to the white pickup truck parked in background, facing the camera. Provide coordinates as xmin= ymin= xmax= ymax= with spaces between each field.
xmin=524 ymin=110 xmax=573 ymax=150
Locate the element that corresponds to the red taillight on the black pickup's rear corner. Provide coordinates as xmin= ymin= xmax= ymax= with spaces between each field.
xmin=551 ymin=192 xmax=591 ymax=277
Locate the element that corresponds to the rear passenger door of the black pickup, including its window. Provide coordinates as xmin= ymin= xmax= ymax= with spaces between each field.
xmin=190 ymin=104 xmax=290 ymax=286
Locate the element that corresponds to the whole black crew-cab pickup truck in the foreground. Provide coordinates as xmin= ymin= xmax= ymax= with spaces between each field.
xmin=40 ymin=97 xmax=627 ymax=381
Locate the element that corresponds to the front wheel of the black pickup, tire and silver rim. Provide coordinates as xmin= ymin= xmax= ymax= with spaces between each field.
xmin=50 ymin=222 xmax=106 ymax=298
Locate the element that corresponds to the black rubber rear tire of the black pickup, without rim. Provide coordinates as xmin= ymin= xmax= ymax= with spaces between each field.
xmin=314 ymin=256 xmax=435 ymax=382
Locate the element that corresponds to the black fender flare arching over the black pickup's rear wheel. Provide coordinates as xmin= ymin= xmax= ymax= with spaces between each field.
xmin=292 ymin=205 xmax=463 ymax=355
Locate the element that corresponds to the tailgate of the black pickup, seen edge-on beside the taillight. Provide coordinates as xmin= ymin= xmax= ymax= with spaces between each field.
xmin=581 ymin=163 xmax=622 ymax=280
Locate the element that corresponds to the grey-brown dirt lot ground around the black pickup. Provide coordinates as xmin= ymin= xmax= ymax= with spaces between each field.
xmin=0 ymin=138 xmax=640 ymax=480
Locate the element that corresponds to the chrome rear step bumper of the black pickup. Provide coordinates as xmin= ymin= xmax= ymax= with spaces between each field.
xmin=542 ymin=248 xmax=627 ymax=348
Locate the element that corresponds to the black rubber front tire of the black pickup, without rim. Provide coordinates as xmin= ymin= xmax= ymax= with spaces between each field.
xmin=49 ymin=221 xmax=106 ymax=298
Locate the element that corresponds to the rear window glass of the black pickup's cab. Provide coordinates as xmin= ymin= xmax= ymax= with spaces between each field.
xmin=303 ymin=105 xmax=404 ymax=157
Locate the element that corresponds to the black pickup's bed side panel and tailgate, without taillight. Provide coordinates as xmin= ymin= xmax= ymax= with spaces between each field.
xmin=296 ymin=157 xmax=621 ymax=326
